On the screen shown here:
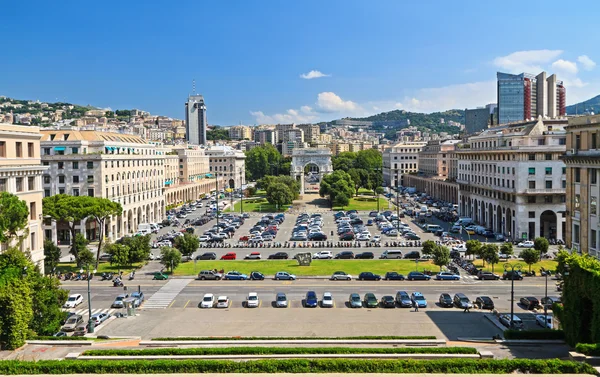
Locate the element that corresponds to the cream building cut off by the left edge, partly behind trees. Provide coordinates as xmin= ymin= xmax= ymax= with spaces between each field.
xmin=0 ymin=124 xmax=47 ymax=273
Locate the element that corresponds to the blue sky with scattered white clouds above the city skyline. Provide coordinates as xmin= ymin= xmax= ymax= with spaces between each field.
xmin=0 ymin=0 xmax=600 ymax=125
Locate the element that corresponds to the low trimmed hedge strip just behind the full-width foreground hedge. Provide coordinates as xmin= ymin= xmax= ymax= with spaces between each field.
xmin=82 ymin=347 xmax=477 ymax=356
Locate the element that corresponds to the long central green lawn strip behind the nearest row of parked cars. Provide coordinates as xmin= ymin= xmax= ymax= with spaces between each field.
xmin=175 ymin=258 xmax=440 ymax=277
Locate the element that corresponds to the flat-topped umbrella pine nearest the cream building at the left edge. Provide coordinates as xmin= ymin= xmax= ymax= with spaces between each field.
xmin=42 ymin=194 xmax=90 ymax=258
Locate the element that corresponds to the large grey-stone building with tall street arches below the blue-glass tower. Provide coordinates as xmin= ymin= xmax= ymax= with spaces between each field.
xmin=457 ymin=117 xmax=567 ymax=239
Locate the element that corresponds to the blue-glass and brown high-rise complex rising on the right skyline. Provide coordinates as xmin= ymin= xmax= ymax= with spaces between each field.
xmin=497 ymin=72 xmax=566 ymax=124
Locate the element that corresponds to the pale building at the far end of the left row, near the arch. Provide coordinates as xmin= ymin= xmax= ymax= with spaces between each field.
xmin=205 ymin=145 xmax=246 ymax=188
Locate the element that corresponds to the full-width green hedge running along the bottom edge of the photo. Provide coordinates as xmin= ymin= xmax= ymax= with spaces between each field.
xmin=0 ymin=359 xmax=596 ymax=375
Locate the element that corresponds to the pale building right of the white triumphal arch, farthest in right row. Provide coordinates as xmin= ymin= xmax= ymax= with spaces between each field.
xmin=383 ymin=142 xmax=426 ymax=188
